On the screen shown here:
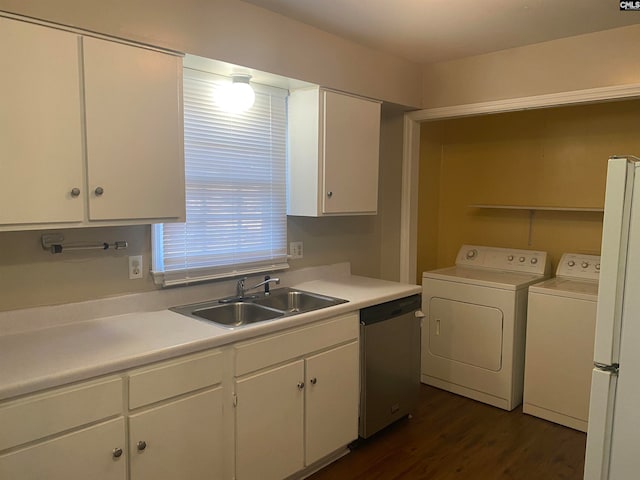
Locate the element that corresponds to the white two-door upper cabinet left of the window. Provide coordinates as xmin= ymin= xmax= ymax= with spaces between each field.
xmin=0 ymin=17 xmax=185 ymax=230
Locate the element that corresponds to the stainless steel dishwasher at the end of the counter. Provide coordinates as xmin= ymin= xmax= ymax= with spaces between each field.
xmin=359 ymin=295 xmax=423 ymax=438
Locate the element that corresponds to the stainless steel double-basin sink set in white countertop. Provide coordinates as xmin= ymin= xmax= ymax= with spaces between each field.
xmin=170 ymin=288 xmax=347 ymax=328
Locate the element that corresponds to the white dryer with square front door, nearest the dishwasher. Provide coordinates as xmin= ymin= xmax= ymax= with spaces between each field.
xmin=421 ymin=245 xmax=549 ymax=410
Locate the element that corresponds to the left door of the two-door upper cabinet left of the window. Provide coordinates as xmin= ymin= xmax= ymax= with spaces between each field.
xmin=0 ymin=18 xmax=84 ymax=225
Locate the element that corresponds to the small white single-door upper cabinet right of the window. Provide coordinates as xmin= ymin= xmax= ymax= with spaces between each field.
xmin=287 ymin=88 xmax=380 ymax=217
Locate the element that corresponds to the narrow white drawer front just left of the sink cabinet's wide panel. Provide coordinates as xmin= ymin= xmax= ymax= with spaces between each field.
xmin=129 ymin=351 xmax=223 ymax=409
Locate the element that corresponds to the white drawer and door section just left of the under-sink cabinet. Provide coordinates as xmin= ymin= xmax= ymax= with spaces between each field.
xmin=128 ymin=350 xmax=224 ymax=480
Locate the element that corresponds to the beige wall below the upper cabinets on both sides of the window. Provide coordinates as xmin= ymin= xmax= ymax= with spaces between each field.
xmin=0 ymin=216 xmax=380 ymax=311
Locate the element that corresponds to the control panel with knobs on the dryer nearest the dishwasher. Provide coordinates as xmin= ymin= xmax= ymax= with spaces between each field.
xmin=456 ymin=245 xmax=549 ymax=275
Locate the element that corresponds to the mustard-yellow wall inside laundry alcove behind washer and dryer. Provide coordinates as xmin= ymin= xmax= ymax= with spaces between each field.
xmin=417 ymin=100 xmax=640 ymax=284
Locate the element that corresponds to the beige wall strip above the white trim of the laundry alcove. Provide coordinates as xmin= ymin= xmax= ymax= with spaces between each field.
xmin=423 ymin=25 xmax=640 ymax=108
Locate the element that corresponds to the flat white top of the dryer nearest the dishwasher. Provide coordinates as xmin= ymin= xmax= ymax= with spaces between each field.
xmin=422 ymin=267 xmax=547 ymax=290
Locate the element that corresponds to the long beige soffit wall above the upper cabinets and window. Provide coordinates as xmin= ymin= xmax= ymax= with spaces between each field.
xmin=0 ymin=0 xmax=422 ymax=107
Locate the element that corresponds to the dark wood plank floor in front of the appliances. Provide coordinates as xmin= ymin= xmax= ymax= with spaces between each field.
xmin=309 ymin=385 xmax=586 ymax=480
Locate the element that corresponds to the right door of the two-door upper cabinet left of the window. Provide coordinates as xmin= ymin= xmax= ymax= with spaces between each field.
xmin=83 ymin=38 xmax=185 ymax=220
